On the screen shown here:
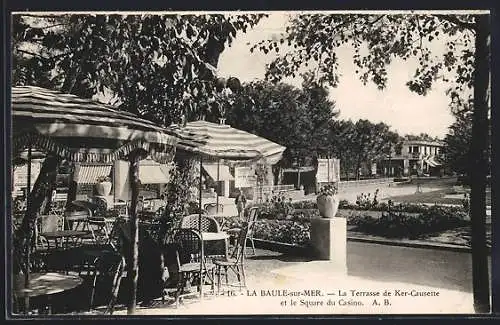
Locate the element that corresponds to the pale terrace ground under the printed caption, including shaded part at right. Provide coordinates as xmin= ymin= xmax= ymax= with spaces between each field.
xmin=102 ymin=242 xmax=480 ymax=316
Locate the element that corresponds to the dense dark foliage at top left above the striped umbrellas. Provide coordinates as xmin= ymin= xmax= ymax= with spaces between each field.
xmin=12 ymin=14 xmax=263 ymax=125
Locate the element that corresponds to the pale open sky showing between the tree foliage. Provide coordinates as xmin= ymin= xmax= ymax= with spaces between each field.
xmin=218 ymin=13 xmax=453 ymax=138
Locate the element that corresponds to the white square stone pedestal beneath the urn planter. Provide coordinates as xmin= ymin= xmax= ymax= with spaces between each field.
xmin=311 ymin=218 xmax=347 ymax=273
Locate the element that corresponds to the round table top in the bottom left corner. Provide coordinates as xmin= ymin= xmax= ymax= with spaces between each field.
xmin=12 ymin=273 xmax=83 ymax=297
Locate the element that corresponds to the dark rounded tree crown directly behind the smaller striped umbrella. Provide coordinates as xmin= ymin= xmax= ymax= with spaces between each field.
xmin=226 ymin=81 xmax=337 ymax=166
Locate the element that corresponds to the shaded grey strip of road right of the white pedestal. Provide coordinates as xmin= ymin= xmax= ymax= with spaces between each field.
xmin=347 ymin=242 xmax=491 ymax=292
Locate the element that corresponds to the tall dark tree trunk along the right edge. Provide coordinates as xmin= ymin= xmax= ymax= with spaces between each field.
xmin=470 ymin=15 xmax=490 ymax=313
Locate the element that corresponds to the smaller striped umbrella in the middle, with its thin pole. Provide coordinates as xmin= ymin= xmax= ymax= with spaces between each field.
xmin=168 ymin=119 xmax=286 ymax=219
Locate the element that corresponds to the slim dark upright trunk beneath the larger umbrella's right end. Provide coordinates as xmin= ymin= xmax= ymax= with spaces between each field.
xmin=127 ymin=152 xmax=140 ymax=315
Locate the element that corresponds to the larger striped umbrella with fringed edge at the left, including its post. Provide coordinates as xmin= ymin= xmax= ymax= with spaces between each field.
xmin=12 ymin=86 xmax=177 ymax=313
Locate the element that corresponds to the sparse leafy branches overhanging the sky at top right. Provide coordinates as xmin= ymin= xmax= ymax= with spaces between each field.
xmin=254 ymin=14 xmax=474 ymax=94
